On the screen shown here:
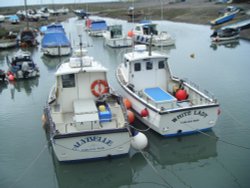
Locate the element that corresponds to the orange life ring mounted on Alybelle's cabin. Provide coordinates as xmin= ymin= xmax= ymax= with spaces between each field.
xmin=91 ymin=80 xmax=109 ymax=97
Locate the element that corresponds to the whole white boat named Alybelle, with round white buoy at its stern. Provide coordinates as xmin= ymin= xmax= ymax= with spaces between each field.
xmin=44 ymin=45 xmax=147 ymax=161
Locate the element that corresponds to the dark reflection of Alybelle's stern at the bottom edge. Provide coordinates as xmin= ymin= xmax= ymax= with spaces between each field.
xmin=53 ymin=155 xmax=146 ymax=188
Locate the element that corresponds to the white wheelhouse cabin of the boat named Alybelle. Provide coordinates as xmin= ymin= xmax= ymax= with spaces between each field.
xmin=53 ymin=56 xmax=107 ymax=113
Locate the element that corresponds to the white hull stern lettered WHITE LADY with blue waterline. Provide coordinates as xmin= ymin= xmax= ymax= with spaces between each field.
xmin=136 ymin=106 xmax=218 ymax=137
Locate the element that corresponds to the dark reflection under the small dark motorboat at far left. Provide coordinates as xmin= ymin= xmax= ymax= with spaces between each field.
xmin=9 ymin=78 xmax=39 ymax=99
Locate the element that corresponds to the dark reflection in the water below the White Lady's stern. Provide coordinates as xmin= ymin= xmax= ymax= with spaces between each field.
xmin=147 ymin=131 xmax=217 ymax=166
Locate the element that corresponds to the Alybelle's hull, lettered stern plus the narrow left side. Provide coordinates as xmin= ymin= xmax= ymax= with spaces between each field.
xmin=44 ymin=107 xmax=131 ymax=162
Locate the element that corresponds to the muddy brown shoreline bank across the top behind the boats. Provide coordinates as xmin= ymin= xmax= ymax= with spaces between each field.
xmin=0 ymin=0 xmax=250 ymax=40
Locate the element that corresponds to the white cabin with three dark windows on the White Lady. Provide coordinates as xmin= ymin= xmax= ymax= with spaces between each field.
xmin=123 ymin=45 xmax=171 ymax=91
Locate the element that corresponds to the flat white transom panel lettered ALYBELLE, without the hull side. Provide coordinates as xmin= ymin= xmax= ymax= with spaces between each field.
xmin=52 ymin=130 xmax=130 ymax=161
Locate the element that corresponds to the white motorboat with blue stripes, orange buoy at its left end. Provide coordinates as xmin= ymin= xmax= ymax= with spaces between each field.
xmin=128 ymin=20 xmax=175 ymax=46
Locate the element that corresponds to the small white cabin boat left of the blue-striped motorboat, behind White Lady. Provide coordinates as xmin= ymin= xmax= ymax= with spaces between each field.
xmin=103 ymin=25 xmax=133 ymax=48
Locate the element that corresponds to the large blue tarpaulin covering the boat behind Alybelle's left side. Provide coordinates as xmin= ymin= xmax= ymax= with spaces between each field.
xmin=42 ymin=24 xmax=70 ymax=48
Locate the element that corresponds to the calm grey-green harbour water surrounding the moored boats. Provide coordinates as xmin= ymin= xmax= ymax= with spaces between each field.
xmin=0 ymin=18 xmax=250 ymax=188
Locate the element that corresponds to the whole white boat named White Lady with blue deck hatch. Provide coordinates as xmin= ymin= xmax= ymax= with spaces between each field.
xmin=116 ymin=45 xmax=219 ymax=137
